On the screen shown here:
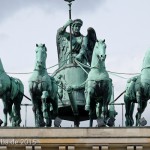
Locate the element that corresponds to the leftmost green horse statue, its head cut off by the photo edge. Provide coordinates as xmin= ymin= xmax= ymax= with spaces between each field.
xmin=0 ymin=59 xmax=24 ymax=127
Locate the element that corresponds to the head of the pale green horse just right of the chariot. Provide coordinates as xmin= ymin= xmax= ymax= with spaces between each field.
xmin=94 ymin=39 xmax=106 ymax=61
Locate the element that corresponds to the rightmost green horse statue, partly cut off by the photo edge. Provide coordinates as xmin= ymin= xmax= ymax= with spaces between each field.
xmin=124 ymin=49 xmax=150 ymax=126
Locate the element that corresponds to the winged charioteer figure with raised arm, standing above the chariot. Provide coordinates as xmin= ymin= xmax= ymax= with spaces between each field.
xmin=56 ymin=19 xmax=97 ymax=67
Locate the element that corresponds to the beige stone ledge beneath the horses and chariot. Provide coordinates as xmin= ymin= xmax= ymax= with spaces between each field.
xmin=0 ymin=127 xmax=150 ymax=150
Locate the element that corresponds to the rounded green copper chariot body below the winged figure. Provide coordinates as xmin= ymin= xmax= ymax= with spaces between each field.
xmin=54 ymin=63 xmax=89 ymax=125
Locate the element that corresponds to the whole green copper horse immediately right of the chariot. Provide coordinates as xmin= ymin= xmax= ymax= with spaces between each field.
xmin=85 ymin=40 xmax=112 ymax=127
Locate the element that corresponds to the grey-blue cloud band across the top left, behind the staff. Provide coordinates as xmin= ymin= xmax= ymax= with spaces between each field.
xmin=0 ymin=0 xmax=106 ymax=22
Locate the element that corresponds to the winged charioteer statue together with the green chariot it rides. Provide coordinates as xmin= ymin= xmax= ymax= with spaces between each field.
xmin=54 ymin=19 xmax=97 ymax=126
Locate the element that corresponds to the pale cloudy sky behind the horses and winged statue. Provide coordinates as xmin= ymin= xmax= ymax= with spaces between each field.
xmin=0 ymin=0 xmax=150 ymax=126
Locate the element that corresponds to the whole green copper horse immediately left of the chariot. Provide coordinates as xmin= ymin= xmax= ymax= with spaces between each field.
xmin=29 ymin=44 xmax=58 ymax=127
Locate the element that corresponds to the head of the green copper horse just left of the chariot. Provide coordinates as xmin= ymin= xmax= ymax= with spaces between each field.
xmin=35 ymin=44 xmax=47 ymax=69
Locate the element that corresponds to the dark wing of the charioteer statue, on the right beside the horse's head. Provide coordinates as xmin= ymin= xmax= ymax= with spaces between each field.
xmin=87 ymin=27 xmax=97 ymax=65
